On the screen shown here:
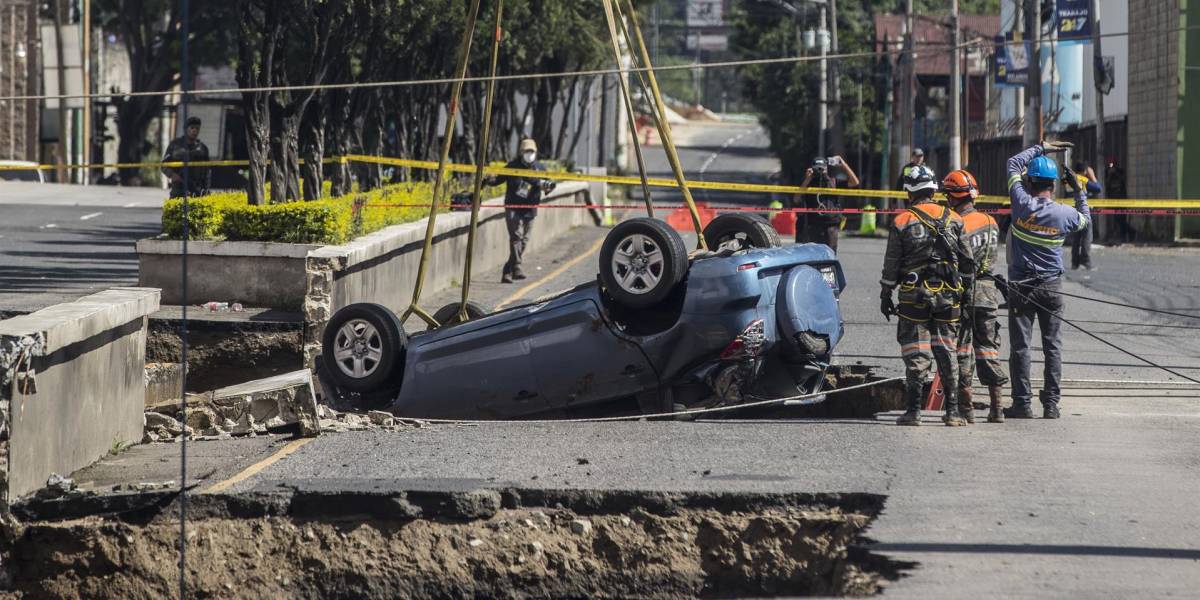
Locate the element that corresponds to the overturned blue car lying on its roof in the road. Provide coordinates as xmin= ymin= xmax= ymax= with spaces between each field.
xmin=318 ymin=214 xmax=846 ymax=419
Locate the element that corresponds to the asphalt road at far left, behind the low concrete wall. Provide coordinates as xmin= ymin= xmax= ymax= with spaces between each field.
xmin=0 ymin=182 xmax=166 ymax=314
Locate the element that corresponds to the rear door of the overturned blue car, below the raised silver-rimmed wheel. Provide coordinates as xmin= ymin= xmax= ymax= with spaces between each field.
xmin=529 ymin=299 xmax=658 ymax=408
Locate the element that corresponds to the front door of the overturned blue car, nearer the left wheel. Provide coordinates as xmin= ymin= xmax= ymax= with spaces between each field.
xmin=396 ymin=313 xmax=547 ymax=419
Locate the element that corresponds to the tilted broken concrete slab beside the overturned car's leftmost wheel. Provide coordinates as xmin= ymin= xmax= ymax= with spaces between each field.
xmin=211 ymin=370 xmax=320 ymax=437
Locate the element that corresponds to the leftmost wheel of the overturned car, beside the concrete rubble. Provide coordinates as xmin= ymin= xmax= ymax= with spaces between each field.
xmin=320 ymin=304 xmax=408 ymax=394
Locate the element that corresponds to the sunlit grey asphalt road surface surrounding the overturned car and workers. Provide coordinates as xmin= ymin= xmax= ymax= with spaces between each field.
xmin=70 ymin=120 xmax=1200 ymax=598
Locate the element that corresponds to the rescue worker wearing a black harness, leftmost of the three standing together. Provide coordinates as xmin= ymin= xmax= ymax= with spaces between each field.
xmin=880 ymin=166 xmax=974 ymax=426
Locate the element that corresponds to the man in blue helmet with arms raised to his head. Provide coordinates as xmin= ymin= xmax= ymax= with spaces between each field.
xmin=1004 ymin=142 xmax=1092 ymax=419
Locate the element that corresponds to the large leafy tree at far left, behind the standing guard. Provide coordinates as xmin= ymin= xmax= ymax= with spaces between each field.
xmin=92 ymin=0 xmax=234 ymax=185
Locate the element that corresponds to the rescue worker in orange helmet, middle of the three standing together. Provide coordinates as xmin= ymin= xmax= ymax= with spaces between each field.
xmin=942 ymin=170 xmax=1008 ymax=422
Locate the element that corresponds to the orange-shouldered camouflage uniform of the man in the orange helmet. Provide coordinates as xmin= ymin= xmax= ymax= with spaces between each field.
xmin=958 ymin=204 xmax=1008 ymax=389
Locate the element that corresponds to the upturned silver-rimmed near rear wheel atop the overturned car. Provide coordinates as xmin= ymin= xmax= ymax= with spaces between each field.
xmin=600 ymin=217 xmax=688 ymax=308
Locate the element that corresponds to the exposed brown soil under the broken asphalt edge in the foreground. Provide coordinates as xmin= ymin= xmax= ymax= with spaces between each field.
xmin=5 ymin=489 xmax=902 ymax=599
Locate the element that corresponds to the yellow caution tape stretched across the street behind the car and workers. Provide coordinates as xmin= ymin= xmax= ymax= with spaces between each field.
xmin=7 ymin=155 xmax=1200 ymax=209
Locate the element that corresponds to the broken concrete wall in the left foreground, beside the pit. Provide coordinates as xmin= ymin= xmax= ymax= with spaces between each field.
xmin=0 ymin=288 xmax=160 ymax=502
